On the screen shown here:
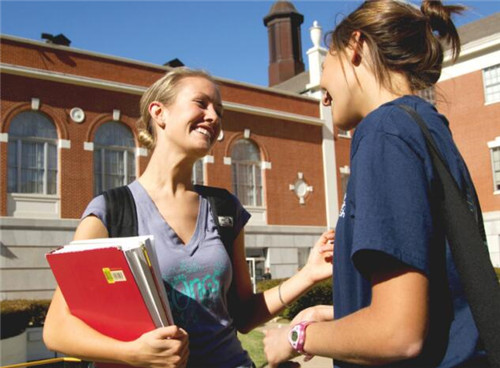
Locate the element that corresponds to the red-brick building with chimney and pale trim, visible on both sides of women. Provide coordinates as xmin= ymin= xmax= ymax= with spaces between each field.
xmin=0 ymin=1 xmax=500 ymax=299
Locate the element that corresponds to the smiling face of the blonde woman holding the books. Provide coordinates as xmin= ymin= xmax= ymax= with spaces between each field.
xmin=150 ymin=77 xmax=222 ymax=157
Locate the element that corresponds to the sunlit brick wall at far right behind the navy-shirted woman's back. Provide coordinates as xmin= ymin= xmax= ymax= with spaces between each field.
xmin=437 ymin=71 xmax=500 ymax=212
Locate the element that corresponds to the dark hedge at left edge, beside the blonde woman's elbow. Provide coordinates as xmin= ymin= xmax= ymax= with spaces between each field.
xmin=0 ymin=299 xmax=50 ymax=339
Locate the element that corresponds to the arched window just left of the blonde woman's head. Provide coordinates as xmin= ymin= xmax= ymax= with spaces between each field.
xmin=94 ymin=122 xmax=135 ymax=195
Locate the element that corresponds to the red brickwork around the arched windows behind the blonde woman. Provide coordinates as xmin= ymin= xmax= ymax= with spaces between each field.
xmin=0 ymin=38 xmax=326 ymax=225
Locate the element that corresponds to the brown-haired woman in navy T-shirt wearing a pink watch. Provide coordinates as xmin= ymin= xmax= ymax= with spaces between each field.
xmin=264 ymin=0 xmax=486 ymax=368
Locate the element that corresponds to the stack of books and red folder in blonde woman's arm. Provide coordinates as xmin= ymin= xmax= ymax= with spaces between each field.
xmin=46 ymin=236 xmax=173 ymax=341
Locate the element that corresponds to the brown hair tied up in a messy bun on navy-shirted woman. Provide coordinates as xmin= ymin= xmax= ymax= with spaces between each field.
xmin=327 ymin=0 xmax=465 ymax=92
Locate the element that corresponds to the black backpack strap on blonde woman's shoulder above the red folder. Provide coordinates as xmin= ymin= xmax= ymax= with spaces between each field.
xmin=102 ymin=185 xmax=138 ymax=238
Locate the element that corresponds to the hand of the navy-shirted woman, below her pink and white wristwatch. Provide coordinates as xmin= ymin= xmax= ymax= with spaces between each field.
xmin=263 ymin=325 xmax=299 ymax=368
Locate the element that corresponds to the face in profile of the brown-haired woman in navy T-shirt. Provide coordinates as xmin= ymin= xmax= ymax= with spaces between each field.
xmin=320 ymin=51 xmax=362 ymax=130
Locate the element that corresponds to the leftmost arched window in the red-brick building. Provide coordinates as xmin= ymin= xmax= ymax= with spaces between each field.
xmin=7 ymin=111 xmax=57 ymax=194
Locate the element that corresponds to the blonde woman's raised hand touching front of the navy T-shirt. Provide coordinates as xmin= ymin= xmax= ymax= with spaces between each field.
xmin=301 ymin=230 xmax=335 ymax=283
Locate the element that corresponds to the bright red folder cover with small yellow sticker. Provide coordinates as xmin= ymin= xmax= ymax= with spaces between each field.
xmin=47 ymin=248 xmax=156 ymax=341
